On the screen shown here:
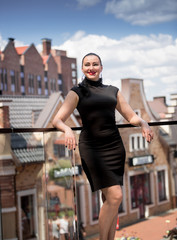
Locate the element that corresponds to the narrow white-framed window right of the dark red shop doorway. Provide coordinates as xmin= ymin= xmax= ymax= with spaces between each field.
xmin=158 ymin=170 xmax=167 ymax=202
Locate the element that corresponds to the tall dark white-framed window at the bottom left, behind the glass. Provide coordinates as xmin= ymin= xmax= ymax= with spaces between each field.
xmin=17 ymin=189 xmax=37 ymax=240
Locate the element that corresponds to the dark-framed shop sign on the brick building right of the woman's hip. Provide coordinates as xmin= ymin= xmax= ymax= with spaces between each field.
xmin=129 ymin=155 xmax=154 ymax=167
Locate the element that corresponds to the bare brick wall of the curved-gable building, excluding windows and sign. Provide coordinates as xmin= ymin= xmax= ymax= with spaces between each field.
xmin=120 ymin=79 xmax=170 ymax=225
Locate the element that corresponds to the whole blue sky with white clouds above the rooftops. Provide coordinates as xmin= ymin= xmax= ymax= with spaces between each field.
xmin=0 ymin=0 xmax=177 ymax=100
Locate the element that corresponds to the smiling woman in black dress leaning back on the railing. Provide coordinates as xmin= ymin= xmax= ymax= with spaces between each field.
xmin=53 ymin=53 xmax=153 ymax=240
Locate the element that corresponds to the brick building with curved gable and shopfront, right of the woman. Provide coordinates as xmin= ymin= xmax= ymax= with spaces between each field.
xmin=115 ymin=79 xmax=176 ymax=225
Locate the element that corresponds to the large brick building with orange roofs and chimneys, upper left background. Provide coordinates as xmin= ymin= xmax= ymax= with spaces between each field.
xmin=0 ymin=38 xmax=77 ymax=96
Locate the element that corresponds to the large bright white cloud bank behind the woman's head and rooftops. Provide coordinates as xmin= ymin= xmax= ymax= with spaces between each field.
xmin=57 ymin=31 xmax=177 ymax=100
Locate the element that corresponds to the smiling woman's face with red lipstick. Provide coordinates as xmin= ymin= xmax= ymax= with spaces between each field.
xmin=82 ymin=55 xmax=103 ymax=81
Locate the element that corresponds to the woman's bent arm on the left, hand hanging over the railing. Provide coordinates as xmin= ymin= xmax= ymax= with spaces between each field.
xmin=52 ymin=91 xmax=79 ymax=150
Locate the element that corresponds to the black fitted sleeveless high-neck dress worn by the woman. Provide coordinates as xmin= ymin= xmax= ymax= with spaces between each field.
xmin=71 ymin=79 xmax=125 ymax=192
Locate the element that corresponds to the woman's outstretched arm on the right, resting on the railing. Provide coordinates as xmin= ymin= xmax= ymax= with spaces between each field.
xmin=116 ymin=91 xmax=154 ymax=142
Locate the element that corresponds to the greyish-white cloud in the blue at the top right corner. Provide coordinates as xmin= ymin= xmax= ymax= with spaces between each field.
xmin=105 ymin=0 xmax=177 ymax=26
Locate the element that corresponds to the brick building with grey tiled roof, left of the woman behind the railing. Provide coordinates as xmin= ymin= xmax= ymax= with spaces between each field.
xmin=0 ymin=92 xmax=80 ymax=240
